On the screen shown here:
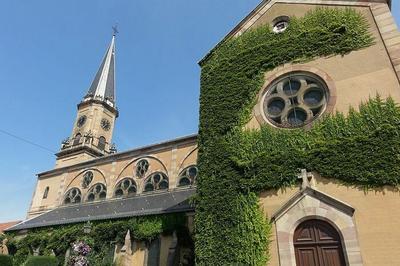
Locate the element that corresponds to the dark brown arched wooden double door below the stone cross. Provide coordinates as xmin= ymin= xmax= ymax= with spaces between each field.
xmin=293 ymin=220 xmax=346 ymax=266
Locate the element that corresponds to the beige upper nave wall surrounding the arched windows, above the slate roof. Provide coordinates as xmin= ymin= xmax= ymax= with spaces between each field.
xmin=28 ymin=136 xmax=197 ymax=218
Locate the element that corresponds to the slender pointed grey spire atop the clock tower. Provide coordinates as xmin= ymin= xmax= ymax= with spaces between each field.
xmin=84 ymin=34 xmax=115 ymax=107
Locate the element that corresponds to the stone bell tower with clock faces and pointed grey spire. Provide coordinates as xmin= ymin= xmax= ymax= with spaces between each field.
xmin=56 ymin=33 xmax=118 ymax=168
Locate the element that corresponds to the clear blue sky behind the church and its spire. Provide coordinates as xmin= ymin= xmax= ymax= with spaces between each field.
xmin=0 ymin=0 xmax=400 ymax=222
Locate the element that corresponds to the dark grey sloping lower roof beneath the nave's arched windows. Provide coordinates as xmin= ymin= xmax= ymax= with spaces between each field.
xmin=6 ymin=189 xmax=195 ymax=231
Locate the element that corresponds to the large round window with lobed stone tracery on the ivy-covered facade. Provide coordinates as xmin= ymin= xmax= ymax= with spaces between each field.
xmin=262 ymin=72 xmax=329 ymax=128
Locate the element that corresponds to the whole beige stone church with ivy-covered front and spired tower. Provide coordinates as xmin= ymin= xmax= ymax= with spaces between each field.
xmin=3 ymin=0 xmax=400 ymax=266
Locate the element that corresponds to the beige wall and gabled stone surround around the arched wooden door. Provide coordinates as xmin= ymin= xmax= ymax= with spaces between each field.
xmin=260 ymin=173 xmax=400 ymax=265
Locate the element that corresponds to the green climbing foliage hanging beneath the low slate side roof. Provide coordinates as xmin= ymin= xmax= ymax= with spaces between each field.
xmin=8 ymin=213 xmax=186 ymax=265
